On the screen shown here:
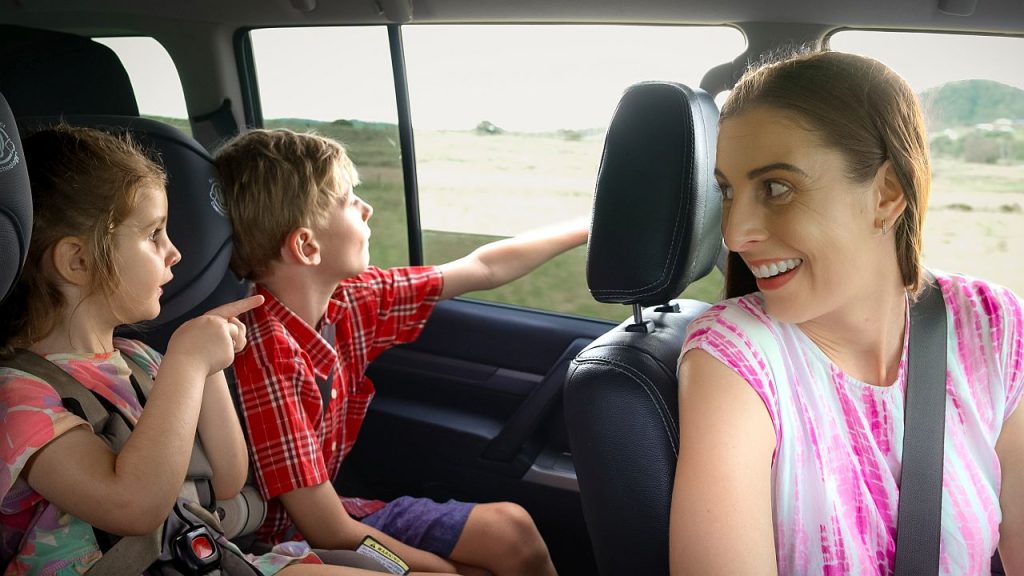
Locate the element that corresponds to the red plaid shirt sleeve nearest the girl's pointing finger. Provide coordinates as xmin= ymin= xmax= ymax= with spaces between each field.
xmin=234 ymin=317 xmax=331 ymax=499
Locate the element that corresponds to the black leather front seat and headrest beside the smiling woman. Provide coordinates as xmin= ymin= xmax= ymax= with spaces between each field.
xmin=564 ymin=82 xmax=722 ymax=576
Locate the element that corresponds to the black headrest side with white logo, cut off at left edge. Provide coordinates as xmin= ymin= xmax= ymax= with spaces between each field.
xmin=0 ymin=90 xmax=32 ymax=301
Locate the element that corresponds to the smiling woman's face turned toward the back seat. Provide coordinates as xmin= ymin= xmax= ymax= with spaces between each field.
xmin=715 ymin=107 xmax=892 ymax=324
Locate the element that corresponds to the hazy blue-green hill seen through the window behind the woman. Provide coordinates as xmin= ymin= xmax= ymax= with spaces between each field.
xmin=920 ymin=80 xmax=1024 ymax=132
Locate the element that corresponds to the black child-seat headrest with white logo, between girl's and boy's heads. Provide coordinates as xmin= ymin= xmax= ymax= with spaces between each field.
xmin=18 ymin=116 xmax=231 ymax=326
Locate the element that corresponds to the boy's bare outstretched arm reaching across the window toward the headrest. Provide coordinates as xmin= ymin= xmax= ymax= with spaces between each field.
xmin=440 ymin=219 xmax=589 ymax=298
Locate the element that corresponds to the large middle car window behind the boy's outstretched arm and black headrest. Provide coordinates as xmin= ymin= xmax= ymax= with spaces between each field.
xmin=402 ymin=25 xmax=744 ymax=321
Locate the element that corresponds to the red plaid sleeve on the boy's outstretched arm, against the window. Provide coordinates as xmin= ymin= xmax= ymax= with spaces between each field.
xmin=336 ymin=266 xmax=444 ymax=362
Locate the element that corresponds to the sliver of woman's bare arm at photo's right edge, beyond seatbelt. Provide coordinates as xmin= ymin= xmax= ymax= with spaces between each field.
xmin=995 ymin=401 xmax=1024 ymax=574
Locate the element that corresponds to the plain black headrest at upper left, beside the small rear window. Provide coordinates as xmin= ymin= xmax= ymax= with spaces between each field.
xmin=0 ymin=26 xmax=138 ymax=117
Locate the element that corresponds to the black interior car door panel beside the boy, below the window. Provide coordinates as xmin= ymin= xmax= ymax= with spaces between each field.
xmin=337 ymin=299 xmax=610 ymax=574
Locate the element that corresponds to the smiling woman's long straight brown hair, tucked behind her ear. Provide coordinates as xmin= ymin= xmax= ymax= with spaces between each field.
xmin=721 ymin=51 xmax=932 ymax=298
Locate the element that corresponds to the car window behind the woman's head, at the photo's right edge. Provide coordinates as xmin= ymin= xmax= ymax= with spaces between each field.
xmin=829 ymin=31 xmax=1024 ymax=294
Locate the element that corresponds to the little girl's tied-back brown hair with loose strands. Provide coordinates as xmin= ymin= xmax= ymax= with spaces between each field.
xmin=0 ymin=125 xmax=166 ymax=352
